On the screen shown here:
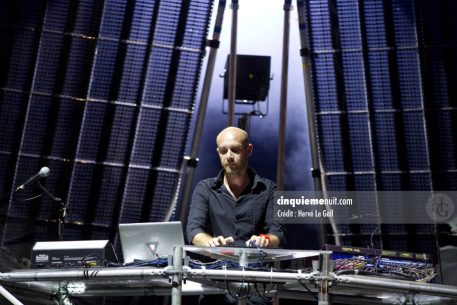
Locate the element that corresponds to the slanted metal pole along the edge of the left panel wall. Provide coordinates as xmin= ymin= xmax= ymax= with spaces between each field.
xmin=172 ymin=0 xmax=227 ymax=223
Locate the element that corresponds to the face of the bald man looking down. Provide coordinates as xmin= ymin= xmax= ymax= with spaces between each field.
xmin=217 ymin=132 xmax=252 ymax=175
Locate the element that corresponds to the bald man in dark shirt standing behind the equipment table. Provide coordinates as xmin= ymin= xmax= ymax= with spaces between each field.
xmin=187 ymin=127 xmax=283 ymax=248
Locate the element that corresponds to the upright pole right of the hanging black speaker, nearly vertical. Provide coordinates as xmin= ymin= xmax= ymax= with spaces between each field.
xmin=276 ymin=0 xmax=292 ymax=191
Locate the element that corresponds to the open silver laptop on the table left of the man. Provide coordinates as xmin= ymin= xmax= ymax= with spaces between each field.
xmin=119 ymin=221 xmax=184 ymax=263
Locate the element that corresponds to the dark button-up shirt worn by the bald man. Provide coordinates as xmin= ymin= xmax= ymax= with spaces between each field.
xmin=187 ymin=168 xmax=283 ymax=244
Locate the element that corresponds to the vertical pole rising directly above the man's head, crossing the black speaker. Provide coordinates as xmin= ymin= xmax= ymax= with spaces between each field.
xmin=228 ymin=0 xmax=239 ymax=126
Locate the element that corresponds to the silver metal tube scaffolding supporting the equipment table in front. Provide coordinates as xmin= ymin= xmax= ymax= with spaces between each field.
xmin=0 ymin=248 xmax=457 ymax=305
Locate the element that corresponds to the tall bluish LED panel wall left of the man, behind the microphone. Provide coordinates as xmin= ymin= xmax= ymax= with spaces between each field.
xmin=0 ymin=0 xmax=212 ymax=266
